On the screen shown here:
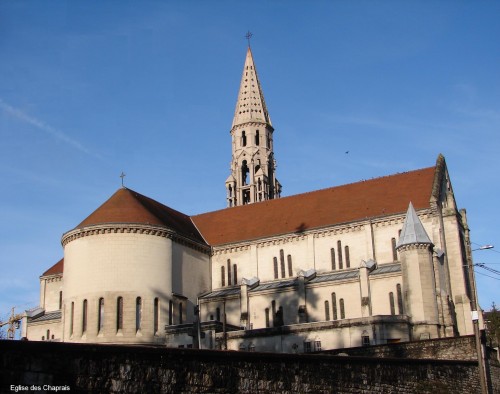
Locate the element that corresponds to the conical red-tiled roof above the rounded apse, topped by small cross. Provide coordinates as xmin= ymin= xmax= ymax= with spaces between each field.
xmin=76 ymin=187 xmax=203 ymax=242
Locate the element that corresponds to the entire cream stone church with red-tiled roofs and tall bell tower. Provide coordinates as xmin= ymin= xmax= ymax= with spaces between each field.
xmin=23 ymin=48 xmax=476 ymax=353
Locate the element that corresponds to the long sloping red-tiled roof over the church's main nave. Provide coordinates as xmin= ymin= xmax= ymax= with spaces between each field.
xmin=191 ymin=167 xmax=436 ymax=246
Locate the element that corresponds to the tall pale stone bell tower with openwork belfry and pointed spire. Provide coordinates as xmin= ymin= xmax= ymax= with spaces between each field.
xmin=226 ymin=46 xmax=281 ymax=207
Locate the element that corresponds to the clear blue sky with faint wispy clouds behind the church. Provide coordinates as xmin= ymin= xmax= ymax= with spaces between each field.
xmin=0 ymin=0 xmax=500 ymax=330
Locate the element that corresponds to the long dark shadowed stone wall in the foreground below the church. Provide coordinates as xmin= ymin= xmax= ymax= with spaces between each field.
xmin=0 ymin=341 xmax=486 ymax=394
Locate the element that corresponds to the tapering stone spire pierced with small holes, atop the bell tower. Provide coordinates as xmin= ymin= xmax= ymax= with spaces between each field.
xmin=233 ymin=47 xmax=272 ymax=128
